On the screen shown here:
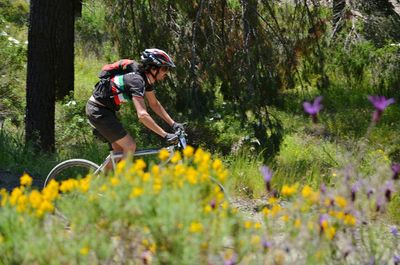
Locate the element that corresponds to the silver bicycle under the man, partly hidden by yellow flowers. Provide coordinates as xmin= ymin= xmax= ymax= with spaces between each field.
xmin=43 ymin=130 xmax=188 ymax=188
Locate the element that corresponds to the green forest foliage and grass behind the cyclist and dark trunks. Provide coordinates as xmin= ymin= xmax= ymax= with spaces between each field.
xmin=0 ymin=0 xmax=400 ymax=219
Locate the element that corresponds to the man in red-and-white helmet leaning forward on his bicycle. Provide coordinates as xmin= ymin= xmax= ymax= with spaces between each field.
xmin=86 ymin=49 xmax=183 ymax=159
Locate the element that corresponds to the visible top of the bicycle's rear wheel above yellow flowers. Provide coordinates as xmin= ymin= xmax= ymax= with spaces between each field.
xmin=43 ymin=159 xmax=99 ymax=187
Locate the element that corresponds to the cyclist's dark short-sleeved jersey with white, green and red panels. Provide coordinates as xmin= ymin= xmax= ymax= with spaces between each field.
xmin=93 ymin=63 xmax=153 ymax=111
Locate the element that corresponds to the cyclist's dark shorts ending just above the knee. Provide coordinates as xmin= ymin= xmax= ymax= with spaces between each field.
xmin=86 ymin=100 xmax=128 ymax=143
